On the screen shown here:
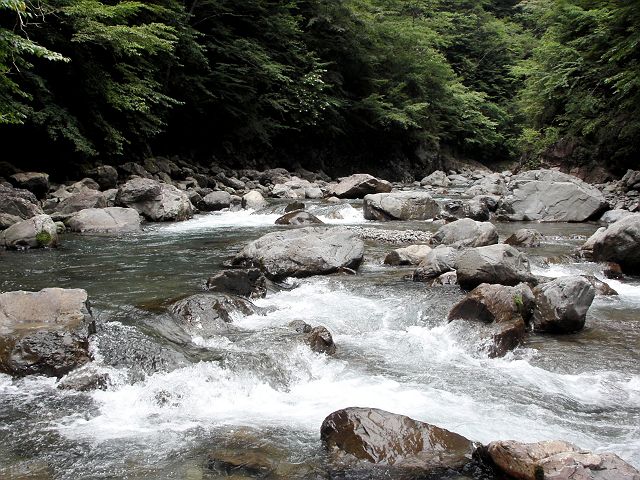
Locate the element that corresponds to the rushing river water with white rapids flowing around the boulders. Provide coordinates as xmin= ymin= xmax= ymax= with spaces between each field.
xmin=0 ymin=204 xmax=640 ymax=479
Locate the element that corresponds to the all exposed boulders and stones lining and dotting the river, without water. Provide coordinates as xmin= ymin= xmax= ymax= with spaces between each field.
xmin=0 ymin=159 xmax=640 ymax=480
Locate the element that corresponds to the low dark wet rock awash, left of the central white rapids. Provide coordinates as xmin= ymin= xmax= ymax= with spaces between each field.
xmin=171 ymin=293 xmax=257 ymax=337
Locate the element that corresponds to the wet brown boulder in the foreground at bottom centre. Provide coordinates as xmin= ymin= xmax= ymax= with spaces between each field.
xmin=320 ymin=407 xmax=474 ymax=474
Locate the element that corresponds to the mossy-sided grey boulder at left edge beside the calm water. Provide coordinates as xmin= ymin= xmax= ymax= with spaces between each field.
xmin=0 ymin=214 xmax=58 ymax=250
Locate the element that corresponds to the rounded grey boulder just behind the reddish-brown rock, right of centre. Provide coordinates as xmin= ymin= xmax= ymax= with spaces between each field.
xmin=456 ymin=244 xmax=535 ymax=290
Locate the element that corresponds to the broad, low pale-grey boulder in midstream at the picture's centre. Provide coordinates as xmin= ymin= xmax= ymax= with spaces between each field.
xmin=232 ymin=227 xmax=364 ymax=280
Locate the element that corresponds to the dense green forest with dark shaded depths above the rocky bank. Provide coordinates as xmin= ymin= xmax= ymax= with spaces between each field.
xmin=0 ymin=0 xmax=640 ymax=177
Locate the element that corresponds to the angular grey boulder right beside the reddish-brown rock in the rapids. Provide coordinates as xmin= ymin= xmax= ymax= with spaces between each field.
xmin=531 ymin=276 xmax=596 ymax=333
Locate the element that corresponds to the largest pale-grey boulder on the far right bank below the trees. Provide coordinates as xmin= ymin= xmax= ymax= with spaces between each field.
xmin=501 ymin=170 xmax=608 ymax=222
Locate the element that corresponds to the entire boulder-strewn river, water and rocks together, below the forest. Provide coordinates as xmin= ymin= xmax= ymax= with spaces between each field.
xmin=0 ymin=163 xmax=640 ymax=479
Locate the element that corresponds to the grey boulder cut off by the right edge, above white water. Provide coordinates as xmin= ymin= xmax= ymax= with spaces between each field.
xmin=583 ymin=214 xmax=640 ymax=275
